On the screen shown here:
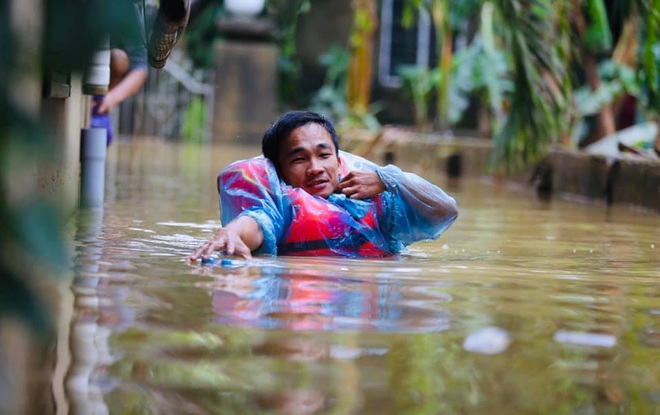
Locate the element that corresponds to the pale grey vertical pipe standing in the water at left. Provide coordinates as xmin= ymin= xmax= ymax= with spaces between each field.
xmin=80 ymin=128 xmax=108 ymax=208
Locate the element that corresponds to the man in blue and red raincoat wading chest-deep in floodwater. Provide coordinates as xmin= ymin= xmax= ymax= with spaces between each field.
xmin=189 ymin=111 xmax=458 ymax=261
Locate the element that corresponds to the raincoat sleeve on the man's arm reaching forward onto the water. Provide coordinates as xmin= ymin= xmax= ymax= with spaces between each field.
xmin=218 ymin=157 xmax=290 ymax=255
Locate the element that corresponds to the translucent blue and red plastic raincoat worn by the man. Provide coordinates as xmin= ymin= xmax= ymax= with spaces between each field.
xmin=218 ymin=151 xmax=457 ymax=257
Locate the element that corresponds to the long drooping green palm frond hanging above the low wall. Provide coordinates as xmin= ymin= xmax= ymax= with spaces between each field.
xmin=492 ymin=0 xmax=568 ymax=170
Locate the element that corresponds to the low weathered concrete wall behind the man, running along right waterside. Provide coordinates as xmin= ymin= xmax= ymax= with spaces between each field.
xmin=340 ymin=129 xmax=660 ymax=212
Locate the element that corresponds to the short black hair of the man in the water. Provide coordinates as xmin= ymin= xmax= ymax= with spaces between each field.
xmin=261 ymin=111 xmax=339 ymax=169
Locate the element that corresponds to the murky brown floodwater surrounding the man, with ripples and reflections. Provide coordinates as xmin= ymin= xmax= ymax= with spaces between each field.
xmin=63 ymin=142 xmax=660 ymax=414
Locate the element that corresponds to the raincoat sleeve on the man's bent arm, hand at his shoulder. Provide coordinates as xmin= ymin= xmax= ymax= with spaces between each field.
xmin=342 ymin=153 xmax=458 ymax=246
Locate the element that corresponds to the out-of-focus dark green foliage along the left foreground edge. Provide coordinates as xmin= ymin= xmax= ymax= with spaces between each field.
xmin=0 ymin=0 xmax=132 ymax=335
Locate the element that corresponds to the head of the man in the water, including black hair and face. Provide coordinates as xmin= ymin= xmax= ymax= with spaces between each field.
xmin=261 ymin=111 xmax=339 ymax=198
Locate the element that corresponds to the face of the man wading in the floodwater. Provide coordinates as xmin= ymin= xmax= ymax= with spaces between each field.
xmin=279 ymin=123 xmax=339 ymax=199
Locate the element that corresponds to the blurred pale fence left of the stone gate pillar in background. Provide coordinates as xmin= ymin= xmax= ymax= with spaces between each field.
xmin=116 ymin=54 xmax=214 ymax=142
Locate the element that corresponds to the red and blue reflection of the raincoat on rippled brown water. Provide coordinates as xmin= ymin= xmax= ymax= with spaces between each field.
xmin=199 ymin=258 xmax=450 ymax=332
